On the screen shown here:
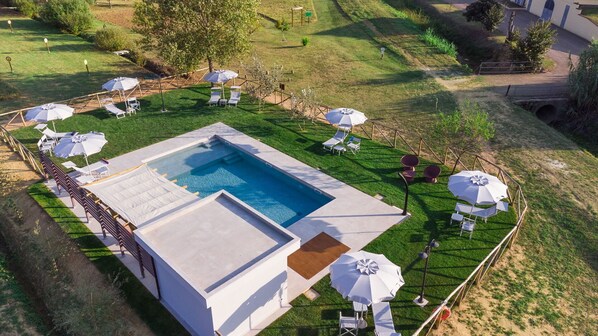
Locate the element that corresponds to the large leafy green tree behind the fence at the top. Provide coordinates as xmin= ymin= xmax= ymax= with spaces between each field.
xmin=133 ymin=0 xmax=259 ymax=71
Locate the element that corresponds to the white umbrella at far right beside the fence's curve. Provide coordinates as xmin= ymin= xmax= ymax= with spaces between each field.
xmin=448 ymin=170 xmax=507 ymax=205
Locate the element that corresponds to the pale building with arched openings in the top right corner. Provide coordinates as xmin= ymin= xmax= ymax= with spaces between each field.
xmin=511 ymin=0 xmax=598 ymax=41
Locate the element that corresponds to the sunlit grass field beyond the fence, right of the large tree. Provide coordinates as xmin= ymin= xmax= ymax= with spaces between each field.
xmin=253 ymin=0 xmax=456 ymax=139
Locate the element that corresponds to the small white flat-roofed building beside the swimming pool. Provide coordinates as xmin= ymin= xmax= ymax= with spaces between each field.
xmin=135 ymin=190 xmax=300 ymax=336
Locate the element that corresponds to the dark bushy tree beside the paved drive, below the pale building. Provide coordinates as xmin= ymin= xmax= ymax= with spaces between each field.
xmin=511 ymin=21 xmax=556 ymax=71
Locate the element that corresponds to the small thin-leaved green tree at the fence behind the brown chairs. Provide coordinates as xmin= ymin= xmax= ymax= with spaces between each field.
xmin=434 ymin=101 xmax=494 ymax=172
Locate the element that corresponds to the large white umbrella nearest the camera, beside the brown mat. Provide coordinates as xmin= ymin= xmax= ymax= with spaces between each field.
xmin=330 ymin=251 xmax=405 ymax=306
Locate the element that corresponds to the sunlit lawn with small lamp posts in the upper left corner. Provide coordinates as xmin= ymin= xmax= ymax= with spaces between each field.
xmin=0 ymin=12 xmax=148 ymax=113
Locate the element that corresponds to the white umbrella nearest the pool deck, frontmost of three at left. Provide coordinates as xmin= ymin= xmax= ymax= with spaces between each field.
xmin=54 ymin=132 xmax=108 ymax=172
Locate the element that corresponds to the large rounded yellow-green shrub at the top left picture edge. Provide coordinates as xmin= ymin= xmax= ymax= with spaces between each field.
xmin=40 ymin=0 xmax=93 ymax=35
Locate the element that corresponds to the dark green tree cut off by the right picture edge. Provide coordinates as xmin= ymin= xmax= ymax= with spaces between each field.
xmin=569 ymin=41 xmax=598 ymax=122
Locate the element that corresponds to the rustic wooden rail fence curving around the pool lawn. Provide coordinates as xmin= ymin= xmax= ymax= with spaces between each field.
xmin=0 ymin=68 xmax=528 ymax=335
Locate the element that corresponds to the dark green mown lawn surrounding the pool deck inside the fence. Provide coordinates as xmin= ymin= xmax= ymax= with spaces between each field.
xmin=14 ymin=86 xmax=515 ymax=335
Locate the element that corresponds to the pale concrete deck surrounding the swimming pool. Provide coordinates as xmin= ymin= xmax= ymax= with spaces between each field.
xmin=52 ymin=123 xmax=409 ymax=333
